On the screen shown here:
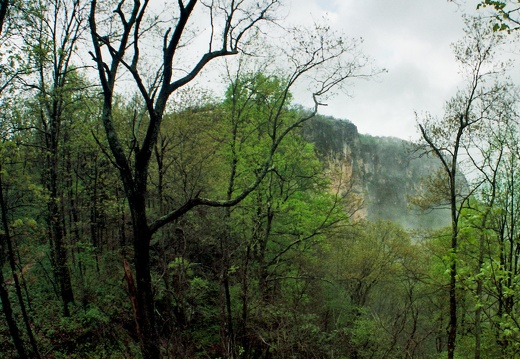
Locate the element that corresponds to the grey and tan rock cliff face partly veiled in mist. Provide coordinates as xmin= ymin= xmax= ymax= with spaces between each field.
xmin=303 ymin=116 xmax=449 ymax=228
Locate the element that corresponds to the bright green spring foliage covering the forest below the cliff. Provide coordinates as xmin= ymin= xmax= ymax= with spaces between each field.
xmin=0 ymin=7 xmax=520 ymax=359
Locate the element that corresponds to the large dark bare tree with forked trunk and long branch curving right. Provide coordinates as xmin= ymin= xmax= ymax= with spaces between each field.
xmin=90 ymin=0 xmax=374 ymax=358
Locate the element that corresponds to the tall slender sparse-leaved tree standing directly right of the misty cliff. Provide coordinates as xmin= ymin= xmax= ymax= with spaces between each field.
xmin=419 ymin=19 xmax=501 ymax=359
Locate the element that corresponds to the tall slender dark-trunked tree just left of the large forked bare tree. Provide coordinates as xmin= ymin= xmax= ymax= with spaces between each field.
xmin=24 ymin=0 xmax=90 ymax=316
